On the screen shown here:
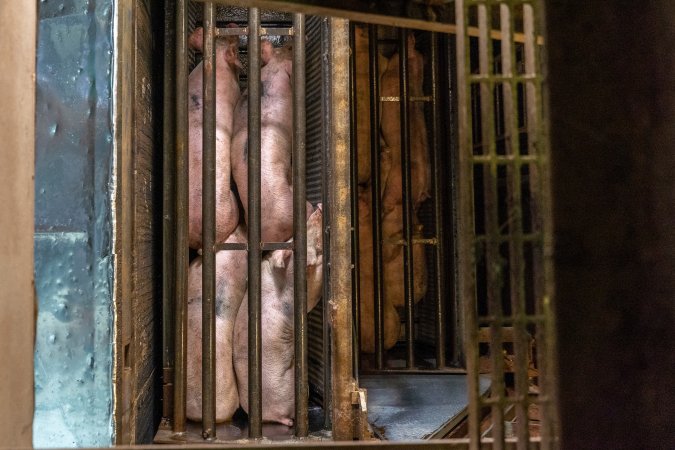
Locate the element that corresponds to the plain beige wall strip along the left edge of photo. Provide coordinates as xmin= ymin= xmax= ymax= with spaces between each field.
xmin=0 ymin=2 xmax=36 ymax=448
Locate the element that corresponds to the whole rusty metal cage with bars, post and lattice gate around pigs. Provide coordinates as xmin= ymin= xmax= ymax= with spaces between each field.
xmin=158 ymin=0 xmax=558 ymax=448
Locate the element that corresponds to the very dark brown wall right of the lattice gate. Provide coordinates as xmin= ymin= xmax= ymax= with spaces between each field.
xmin=546 ymin=0 xmax=675 ymax=449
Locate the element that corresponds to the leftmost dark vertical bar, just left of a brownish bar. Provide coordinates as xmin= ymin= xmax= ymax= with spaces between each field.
xmin=162 ymin=0 xmax=176 ymax=418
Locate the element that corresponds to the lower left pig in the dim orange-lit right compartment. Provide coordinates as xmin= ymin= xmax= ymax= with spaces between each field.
xmin=359 ymin=188 xmax=401 ymax=353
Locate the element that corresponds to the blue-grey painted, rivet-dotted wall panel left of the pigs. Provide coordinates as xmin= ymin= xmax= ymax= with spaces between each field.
xmin=33 ymin=0 xmax=113 ymax=447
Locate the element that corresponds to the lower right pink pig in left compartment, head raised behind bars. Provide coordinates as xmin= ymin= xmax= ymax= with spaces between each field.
xmin=234 ymin=206 xmax=323 ymax=427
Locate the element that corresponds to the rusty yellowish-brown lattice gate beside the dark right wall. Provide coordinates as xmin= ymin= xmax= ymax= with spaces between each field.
xmin=456 ymin=0 xmax=557 ymax=449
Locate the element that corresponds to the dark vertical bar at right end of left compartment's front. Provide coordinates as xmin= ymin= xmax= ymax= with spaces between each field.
xmin=292 ymin=14 xmax=309 ymax=437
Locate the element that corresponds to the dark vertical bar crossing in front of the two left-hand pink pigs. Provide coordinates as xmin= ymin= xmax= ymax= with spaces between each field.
xmin=202 ymin=2 xmax=216 ymax=440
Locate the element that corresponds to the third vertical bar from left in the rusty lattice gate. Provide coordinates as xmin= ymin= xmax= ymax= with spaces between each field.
xmin=499 ymin=3 xmax=529 ymax=449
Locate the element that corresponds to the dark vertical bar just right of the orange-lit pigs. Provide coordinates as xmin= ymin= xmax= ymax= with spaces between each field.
xmin=434 ymin=33 xmax=446 ymax=369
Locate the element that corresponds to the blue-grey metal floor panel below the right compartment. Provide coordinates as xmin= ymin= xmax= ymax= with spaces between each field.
xmin=359 ymin=374 xmax=490 ymax=441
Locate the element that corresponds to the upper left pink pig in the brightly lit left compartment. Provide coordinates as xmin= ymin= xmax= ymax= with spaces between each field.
xmin=188 ymin=24 xmax=241 ymax=250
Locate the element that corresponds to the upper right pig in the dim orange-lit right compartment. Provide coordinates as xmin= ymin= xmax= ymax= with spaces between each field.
xmin=380 ymin=34 xmax=431 ymax=214
